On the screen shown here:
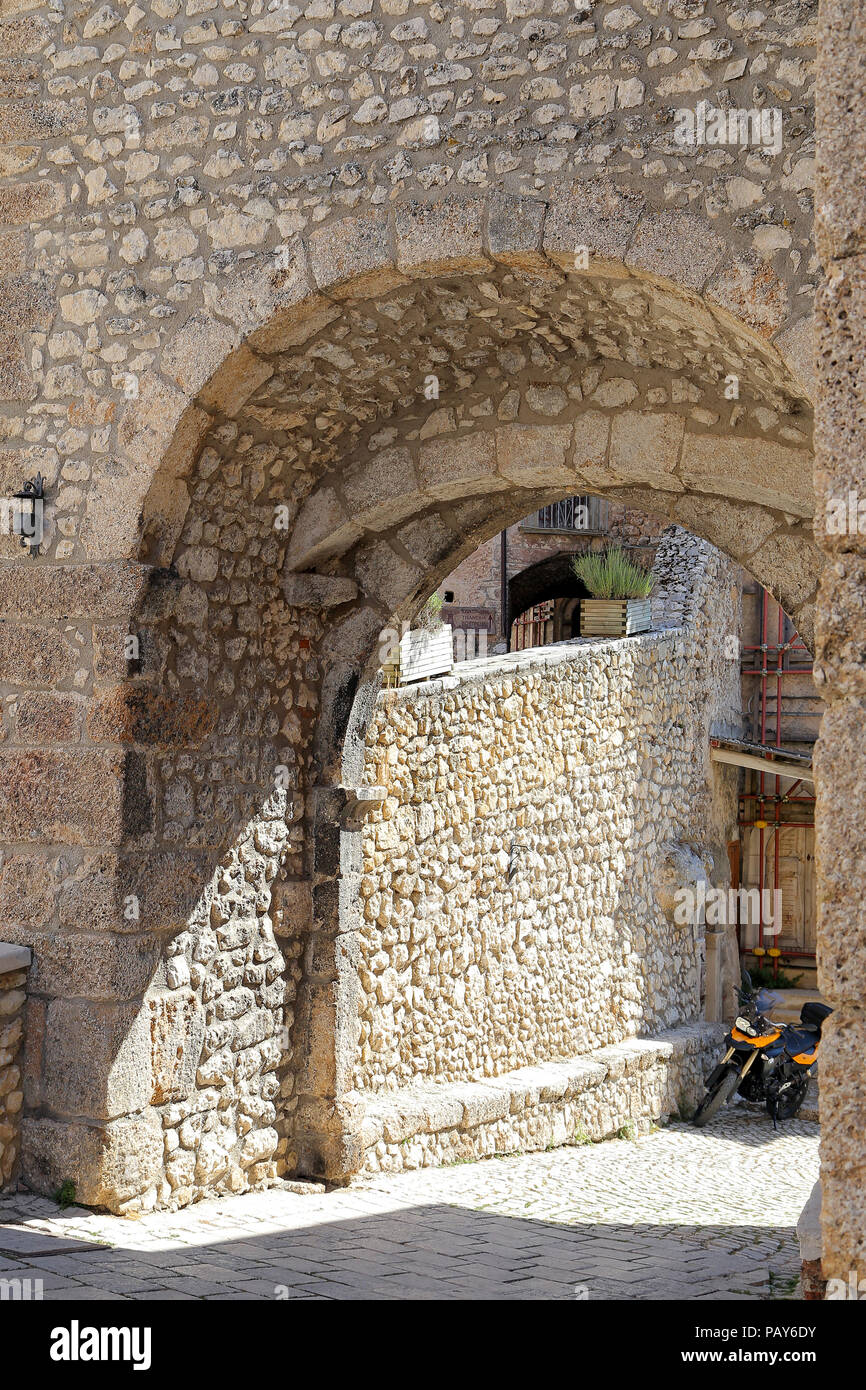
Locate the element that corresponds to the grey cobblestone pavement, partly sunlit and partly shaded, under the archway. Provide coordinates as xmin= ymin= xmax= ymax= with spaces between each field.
xmin=0 ymin=1106 xmax=819 ymax=1300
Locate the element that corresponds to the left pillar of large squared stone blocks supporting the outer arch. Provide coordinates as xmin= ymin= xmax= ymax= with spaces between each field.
xmin=0 ymin=560 xmax=194 ymax=1209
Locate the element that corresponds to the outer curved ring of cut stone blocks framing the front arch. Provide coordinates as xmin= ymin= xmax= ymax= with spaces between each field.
xmin=116 ymin=193 xmax=810 ymax=563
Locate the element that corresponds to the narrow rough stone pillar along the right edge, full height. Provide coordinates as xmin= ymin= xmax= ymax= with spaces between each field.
xmin=815 ymin=0 xmax=866 ymax=1280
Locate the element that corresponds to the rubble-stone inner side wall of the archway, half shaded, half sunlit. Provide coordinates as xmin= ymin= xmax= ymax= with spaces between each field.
xmin=136 ymin=447 xmax=318 ymax=1207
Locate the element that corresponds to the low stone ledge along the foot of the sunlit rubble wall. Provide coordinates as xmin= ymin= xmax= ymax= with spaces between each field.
xmin=360 ymin=1022 xmax=724 ymax=1170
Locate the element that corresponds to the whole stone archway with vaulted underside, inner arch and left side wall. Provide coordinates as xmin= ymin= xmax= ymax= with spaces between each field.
xmin=10 ymin=200 xmax=817 ymax=1207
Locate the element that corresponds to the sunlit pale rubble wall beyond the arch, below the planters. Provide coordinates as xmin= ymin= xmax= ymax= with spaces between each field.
xmin=354 ymin=528 xmax=740 ymax=1145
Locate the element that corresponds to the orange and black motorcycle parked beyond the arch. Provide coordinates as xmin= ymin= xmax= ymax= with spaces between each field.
xmin=692 ymin=970 xmax=833 ymax=1129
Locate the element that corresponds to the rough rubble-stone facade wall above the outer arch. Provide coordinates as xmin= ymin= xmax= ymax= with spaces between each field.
xmin=0 ymin=0 xmax=815 ymax=560
